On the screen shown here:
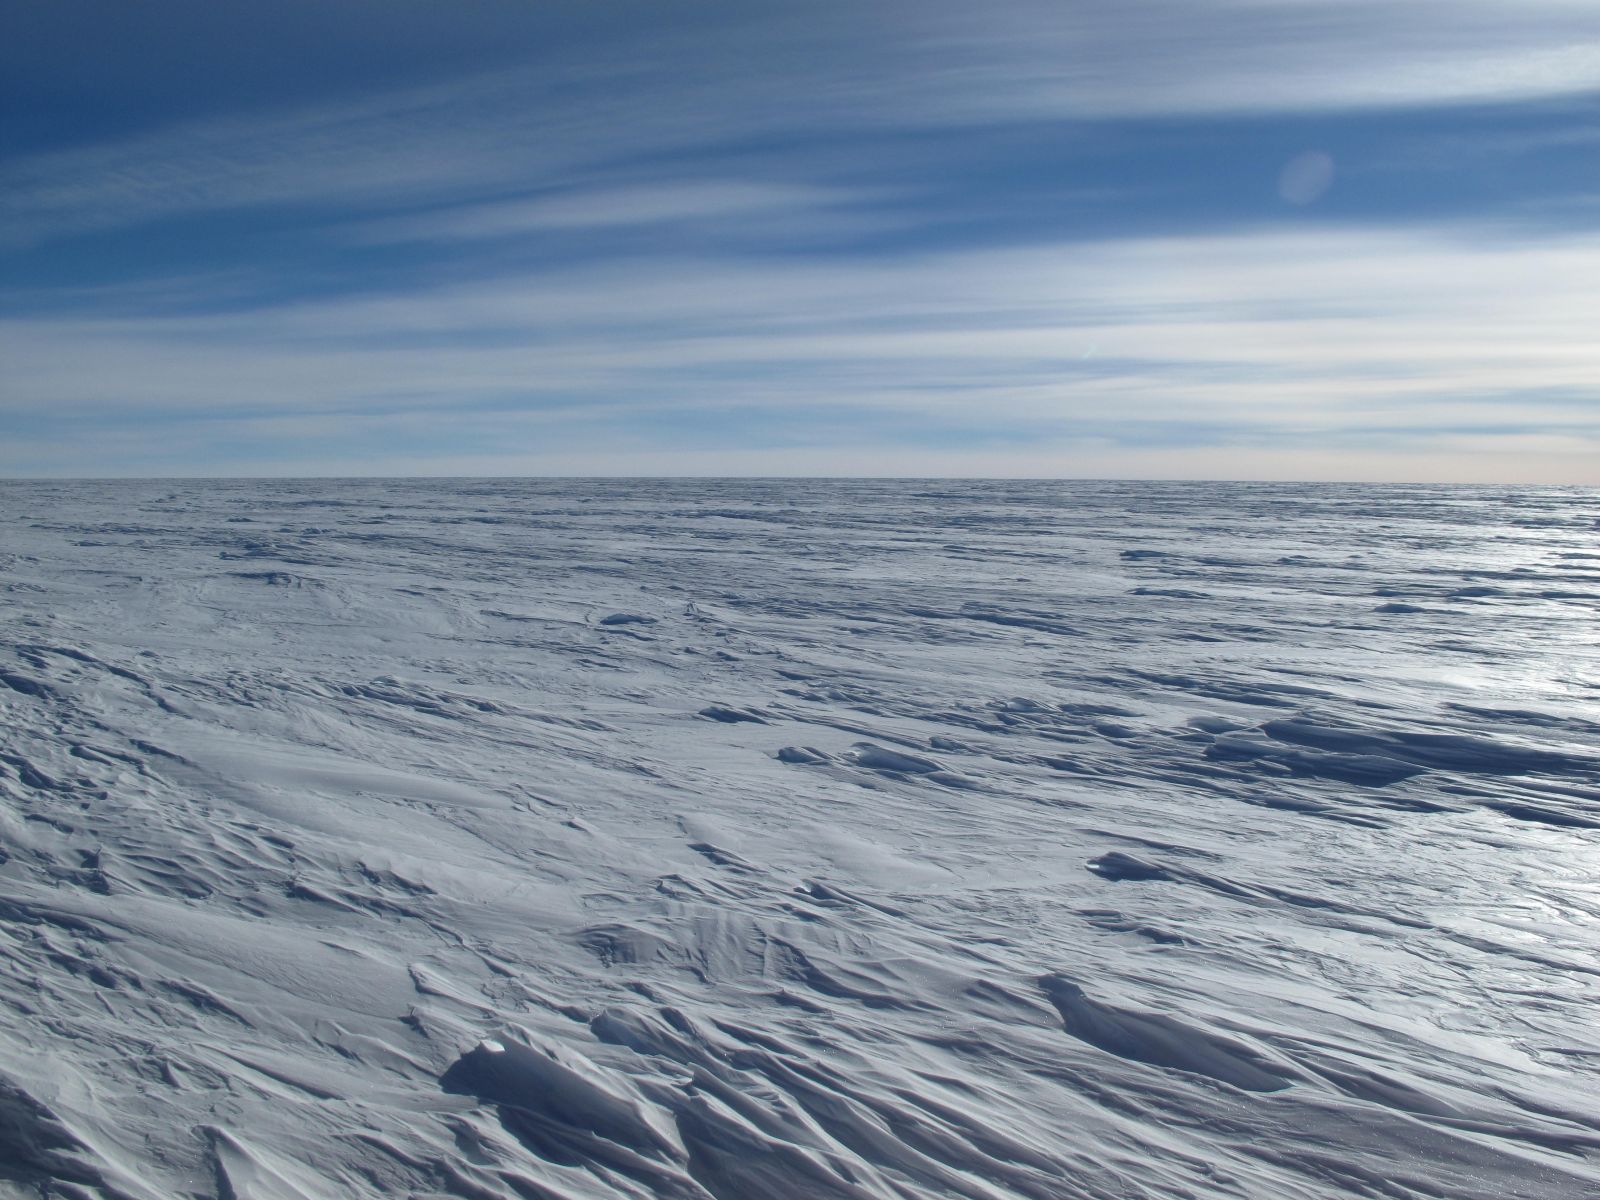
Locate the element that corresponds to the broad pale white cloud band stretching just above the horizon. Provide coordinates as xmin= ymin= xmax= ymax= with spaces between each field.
xmin=3 ymin=229 xmax=1600 ymax=475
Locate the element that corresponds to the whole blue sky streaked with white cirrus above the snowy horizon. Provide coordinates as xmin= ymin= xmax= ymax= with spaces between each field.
xmin=0 ymin=0 xmax=1600 ymax=485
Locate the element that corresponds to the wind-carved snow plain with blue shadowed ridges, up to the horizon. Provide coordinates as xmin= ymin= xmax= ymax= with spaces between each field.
xmin=0 ymin=482 xmax=1600 ymax=1200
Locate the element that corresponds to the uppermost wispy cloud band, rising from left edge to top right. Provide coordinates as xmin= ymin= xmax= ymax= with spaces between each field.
xmin=0 ymin=0 xmax=1600 ymax=249
